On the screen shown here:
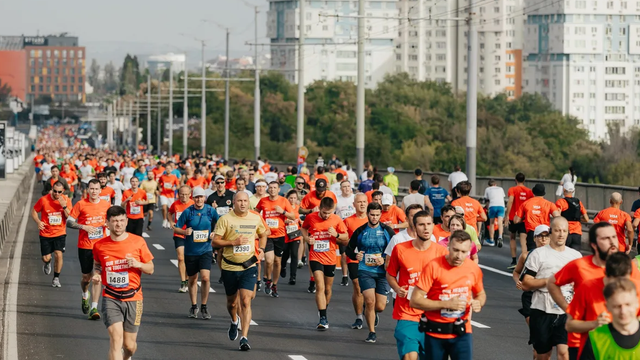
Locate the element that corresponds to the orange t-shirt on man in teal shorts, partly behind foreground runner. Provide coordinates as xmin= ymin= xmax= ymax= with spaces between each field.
xmin=387 ymin=241 xmax=449 ymax=322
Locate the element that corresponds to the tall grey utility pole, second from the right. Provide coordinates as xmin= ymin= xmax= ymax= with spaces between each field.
xmin=356 ymin=0 xmax=365 ymax=174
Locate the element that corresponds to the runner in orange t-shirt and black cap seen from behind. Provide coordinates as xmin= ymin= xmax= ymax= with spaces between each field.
xmin=513 ymin=184 xmax=560 ymax=253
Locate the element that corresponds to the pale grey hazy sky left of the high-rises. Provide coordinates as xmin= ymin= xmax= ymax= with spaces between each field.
xmin=0 ymin=0 xmax=268 ymax=63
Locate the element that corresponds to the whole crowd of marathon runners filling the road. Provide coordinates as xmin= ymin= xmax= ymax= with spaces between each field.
xmin=31 ymin=129 xmax=640 ymax=360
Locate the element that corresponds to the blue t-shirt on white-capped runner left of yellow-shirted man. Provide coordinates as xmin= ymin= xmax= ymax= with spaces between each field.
xmin=176 ymin=204 xmax=220 ymax=256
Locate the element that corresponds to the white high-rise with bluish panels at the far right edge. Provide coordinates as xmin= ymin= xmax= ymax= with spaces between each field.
xmin=523 ymin=0 xmax=640 ymax=140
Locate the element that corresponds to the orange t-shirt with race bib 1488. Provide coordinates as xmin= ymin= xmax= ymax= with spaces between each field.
xmin=93 ymin=233 xmax=153 ymax=301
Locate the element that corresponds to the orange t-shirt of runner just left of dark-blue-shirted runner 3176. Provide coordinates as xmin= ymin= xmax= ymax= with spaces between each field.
xmin=302 ymin=212 xmax=347 ymax=265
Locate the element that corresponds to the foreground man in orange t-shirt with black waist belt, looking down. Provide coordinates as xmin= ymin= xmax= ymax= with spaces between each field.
xmin=409 ymin=231 xmax=487 ymax=359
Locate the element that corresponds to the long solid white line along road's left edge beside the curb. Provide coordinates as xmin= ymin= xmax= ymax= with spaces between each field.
xmin=2 ymin=175 xmax=36 ymax=359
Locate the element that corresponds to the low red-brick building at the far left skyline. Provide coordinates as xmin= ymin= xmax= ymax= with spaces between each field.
xmin=0 ymin=34 xmax=85 ymax=103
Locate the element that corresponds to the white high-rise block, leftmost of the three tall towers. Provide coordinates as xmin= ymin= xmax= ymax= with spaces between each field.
xmin=267 ymin=0 xmax=398 ymax=88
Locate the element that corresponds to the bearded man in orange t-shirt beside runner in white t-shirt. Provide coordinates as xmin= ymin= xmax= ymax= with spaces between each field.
xmin=547 ymin=222 xmax=619 ymax=360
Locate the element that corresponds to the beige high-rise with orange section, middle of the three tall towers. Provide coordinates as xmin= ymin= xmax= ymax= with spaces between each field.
xmin=395 ymin=0 xmax=524 ymax=99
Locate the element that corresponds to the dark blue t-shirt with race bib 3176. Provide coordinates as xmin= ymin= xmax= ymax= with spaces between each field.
xmin=347 ymin=223 xmax=395 ymax=274
